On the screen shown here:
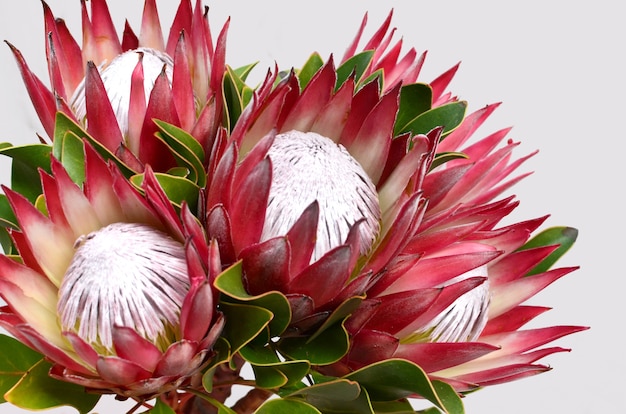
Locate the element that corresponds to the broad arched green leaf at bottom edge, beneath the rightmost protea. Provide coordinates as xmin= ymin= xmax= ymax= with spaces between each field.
xmin=344 ymin=359 xmax=464 ymax=414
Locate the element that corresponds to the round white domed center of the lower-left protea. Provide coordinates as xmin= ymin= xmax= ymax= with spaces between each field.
xmin=57 ymin=223 xmax=189 ymax=350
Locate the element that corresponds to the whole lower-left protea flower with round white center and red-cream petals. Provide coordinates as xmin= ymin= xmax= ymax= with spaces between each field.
xmin=0 ymin=145 xmax=223 ymax=400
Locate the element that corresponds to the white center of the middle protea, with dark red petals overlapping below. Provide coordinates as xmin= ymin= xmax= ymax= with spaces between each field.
xmin=262 ymin=131 xmax=381 ymax=262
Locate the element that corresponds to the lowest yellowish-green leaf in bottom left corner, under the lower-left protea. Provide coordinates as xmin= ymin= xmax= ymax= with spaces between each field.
xmin=4 ymin=359 xmax=100 ymax=413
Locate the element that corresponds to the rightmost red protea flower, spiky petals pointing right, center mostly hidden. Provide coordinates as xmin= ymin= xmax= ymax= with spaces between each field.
xmin=336 ymin=101 xmax=585 ymax=391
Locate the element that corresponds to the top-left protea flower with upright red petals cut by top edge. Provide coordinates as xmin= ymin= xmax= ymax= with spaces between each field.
xmin=9 ymin=0 xmax=228 ymax=172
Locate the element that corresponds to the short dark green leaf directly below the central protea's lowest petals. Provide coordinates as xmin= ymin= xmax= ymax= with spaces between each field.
xmin=278 ymin=323 xmax=350 ymax=365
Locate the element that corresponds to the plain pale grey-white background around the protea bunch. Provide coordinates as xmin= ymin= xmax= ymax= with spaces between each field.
xmin=0 ymin=0 xmax=626 ymax=414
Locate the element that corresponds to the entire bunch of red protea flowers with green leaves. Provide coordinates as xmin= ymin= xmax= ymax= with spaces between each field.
xmin=0 ymin=0 xmax=585 ymax=413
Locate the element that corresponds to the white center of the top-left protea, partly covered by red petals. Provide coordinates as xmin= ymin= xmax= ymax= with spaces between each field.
xmin=70 ymin=47 xmax=174 ymax=136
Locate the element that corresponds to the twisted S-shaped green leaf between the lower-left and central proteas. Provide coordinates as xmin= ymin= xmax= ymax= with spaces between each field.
xmin=214 ymin=262 xmax=291 ymax=336
